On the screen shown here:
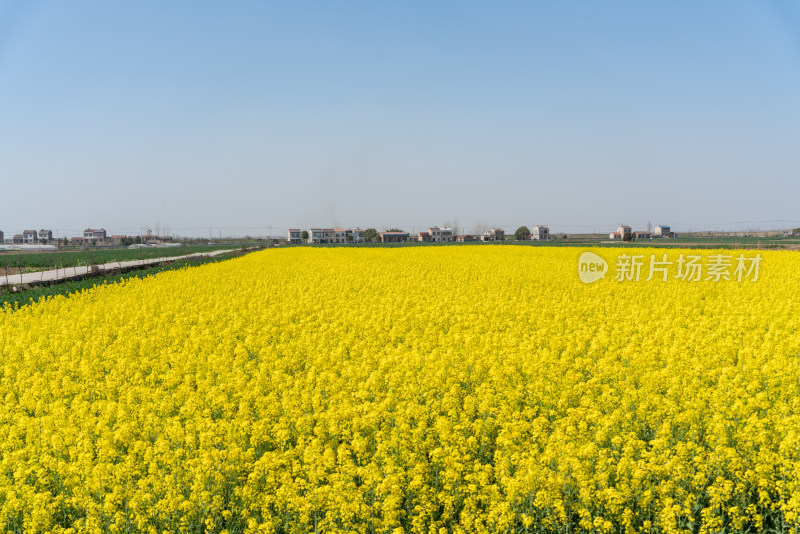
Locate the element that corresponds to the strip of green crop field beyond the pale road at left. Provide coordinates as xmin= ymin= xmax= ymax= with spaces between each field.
xmin=0 ymin=245 xmax=237 ymax=275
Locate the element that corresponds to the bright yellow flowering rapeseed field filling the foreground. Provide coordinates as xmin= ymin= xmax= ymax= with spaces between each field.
xmin=0 ymin=246 xmax=800 ymax=533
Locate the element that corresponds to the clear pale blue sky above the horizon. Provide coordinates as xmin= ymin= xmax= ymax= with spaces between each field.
xmin=0 ymin=0 xmax=800 ymax=237
